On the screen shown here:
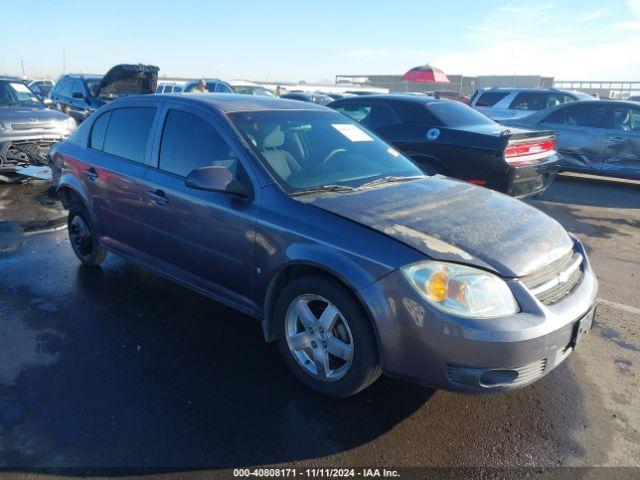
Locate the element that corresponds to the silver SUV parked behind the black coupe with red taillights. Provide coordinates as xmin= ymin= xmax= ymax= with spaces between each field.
xmin=469 ymin=88 xmax=593 ymax=121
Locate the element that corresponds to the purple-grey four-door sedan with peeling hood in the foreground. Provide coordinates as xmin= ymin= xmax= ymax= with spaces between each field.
xmin=52 ymin=95 xmax=597 ymax=397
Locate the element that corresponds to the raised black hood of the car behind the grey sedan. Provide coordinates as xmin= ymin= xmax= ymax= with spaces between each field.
xmin=96 ymin=64 xmax=160 ymax=99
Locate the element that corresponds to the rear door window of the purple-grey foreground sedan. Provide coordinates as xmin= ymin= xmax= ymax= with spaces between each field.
xmin=103 ymin=107 xmax=156 ymax=163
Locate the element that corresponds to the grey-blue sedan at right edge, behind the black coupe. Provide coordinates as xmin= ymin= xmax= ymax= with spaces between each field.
xmin=508 ymin=100 xmax=640 ymax=179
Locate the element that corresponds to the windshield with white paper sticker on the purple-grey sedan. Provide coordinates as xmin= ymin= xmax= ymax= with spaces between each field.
xmin=230 ymin=110 xmax=423 ymax=193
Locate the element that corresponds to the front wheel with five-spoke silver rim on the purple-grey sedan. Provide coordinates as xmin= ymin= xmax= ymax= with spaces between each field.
xmin=274 ymin=275 xmax=381 ymax=397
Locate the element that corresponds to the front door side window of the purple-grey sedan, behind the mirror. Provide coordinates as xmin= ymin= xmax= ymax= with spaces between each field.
xmin=159 ymin=110 xmax=238 ymax=177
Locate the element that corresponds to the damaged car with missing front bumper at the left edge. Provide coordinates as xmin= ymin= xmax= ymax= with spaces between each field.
xmin=0 ymin=77 xmax=76 ymax=182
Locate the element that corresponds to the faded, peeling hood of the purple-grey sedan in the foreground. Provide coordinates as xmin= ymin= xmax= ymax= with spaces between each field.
xmin=299 ymin=175 xmax=573 ymax=277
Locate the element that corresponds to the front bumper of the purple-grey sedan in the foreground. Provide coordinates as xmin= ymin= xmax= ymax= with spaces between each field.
xmin=360 ymin=238 xmax=598 ymax=392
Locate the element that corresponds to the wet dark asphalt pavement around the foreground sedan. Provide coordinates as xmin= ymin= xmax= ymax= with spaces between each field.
xmin=0 ymin=176 xmax=640 ymax=478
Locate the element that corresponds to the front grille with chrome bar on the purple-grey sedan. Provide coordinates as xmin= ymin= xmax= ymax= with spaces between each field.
xmin=520 ymin=250 xmax=584 ymax=305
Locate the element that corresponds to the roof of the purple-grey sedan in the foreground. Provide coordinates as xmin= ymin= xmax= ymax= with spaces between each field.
xmin=109 ymin=93 xmax=332 ymax=113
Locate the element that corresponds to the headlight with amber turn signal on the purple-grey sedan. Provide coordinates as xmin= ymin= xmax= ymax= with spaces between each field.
xmin=402 ymin=260 xmax=520 ymax=318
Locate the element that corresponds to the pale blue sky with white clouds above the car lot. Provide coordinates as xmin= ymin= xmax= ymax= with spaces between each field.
xmin=0 ymin=0 xmax=640 ymax=82
